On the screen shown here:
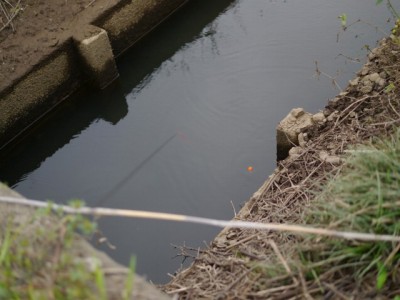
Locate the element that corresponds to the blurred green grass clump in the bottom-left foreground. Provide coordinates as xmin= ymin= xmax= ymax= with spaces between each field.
xmin=0 ymin=202 xmax=133 ymax=300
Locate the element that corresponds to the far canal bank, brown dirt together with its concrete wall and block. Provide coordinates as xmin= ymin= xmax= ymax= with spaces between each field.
xmin=0 ymin=0 xmax=186 ymax=149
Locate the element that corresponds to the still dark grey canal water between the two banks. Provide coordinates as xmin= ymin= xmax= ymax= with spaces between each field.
xmin=0 ymin=0 xmax=390 ymax=283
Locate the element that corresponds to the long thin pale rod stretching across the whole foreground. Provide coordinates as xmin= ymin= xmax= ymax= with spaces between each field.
xmin=0 ymin=196 xmax=400 ymax=242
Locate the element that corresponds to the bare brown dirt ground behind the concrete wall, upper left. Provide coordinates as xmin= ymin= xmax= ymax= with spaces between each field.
xmin=0 ymin=0 xmax=120 ymax=93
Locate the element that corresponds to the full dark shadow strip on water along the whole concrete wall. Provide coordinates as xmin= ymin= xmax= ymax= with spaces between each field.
xmin=0 ymin=0 xmax=235 ymax=187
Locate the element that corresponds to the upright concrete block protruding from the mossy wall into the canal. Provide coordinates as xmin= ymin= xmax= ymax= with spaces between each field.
xmin=73 ymin=25 xmax=118 ymax=89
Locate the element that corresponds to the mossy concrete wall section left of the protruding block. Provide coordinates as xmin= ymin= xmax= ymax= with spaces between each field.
xmin=0 ymin=42 xmax=85 ymax=149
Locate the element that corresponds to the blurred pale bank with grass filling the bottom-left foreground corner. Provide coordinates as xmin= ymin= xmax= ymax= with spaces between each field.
xmin=0 ymin=184 xmax=170 ymax=300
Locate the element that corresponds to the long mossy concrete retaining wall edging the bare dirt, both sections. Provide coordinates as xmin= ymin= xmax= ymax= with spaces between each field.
xmin=0 ymin=0 xmax=187 ymax=150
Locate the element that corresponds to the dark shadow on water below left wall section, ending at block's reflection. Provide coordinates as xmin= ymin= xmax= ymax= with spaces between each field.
xmin=0 ymin=85 xmax=128 ymax=187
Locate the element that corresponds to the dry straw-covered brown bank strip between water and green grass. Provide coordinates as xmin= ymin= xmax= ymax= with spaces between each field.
xmin=162 ymin=32 xmax=400 ymax=299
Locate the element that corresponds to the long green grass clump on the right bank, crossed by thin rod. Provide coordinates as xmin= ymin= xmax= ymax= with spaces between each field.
xmin=299 ymin=130 xmax=400 ymax=299
